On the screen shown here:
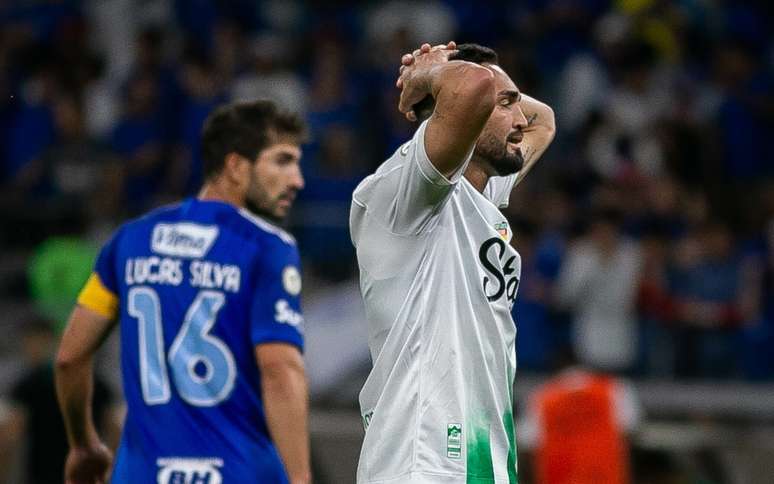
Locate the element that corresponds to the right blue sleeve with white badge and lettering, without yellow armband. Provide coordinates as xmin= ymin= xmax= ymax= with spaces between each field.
xmin=250 ymin=243 xmax=304 ymax=351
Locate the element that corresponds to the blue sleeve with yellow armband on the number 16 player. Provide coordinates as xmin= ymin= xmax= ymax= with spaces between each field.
xmin=78 ymin=230 xmax=121 ymax=319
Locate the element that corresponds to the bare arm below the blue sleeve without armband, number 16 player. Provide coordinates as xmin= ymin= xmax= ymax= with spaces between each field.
xmin=261 ymin=365 xmax=311 ymax=484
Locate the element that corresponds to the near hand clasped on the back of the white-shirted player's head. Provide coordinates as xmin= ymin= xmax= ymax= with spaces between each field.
xmin=395 ymin=41 xmax=457 ymax=121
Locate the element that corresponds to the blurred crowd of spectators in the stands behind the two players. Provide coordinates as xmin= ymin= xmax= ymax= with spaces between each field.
xmin=0 ymin=0 xmax=774 ymax=386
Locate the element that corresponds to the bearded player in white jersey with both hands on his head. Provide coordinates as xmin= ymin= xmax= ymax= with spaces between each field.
xmin=350 ymin=43 xmax=555 ymax=484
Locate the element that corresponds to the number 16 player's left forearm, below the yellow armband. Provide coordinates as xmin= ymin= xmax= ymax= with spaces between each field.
xmin=55 ymin=352 xmax=98 ymax=447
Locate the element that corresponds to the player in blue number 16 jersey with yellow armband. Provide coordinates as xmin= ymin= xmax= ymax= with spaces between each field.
xmin=56 ymin=101 xmax=311 ymax=484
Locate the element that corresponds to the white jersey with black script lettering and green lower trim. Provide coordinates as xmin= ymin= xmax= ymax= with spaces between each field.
xmin=350 ymin=122 xmax=521 ymax=484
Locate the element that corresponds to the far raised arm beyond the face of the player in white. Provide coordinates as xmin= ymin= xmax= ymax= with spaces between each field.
xmin=515 ymin=93 xmax=556 ymax=184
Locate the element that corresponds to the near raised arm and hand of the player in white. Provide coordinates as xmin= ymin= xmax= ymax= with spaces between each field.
xmin=398 ymin=44 xmax=495 ymax=177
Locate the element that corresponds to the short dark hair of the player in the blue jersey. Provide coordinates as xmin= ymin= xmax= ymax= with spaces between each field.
xmin=201 ymin=101 xmax=306 ymax=180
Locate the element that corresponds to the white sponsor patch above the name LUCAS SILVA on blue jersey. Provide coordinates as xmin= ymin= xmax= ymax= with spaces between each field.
xmin=151 ymin=222 xmax=218 ymax=258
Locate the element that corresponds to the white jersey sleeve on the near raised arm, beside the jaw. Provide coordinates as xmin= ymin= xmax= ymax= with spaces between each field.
xmin=352 ymin=121 xmax=473 ymax=235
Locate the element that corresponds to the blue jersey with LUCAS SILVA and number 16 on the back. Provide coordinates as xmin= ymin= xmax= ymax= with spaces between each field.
xmin=79 ymin=199 xmax=303 ymax=484
